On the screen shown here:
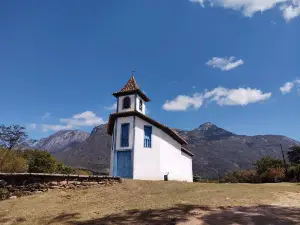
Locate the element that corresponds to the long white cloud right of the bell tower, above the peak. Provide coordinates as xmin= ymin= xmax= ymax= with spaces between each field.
xmin=163 ymin=87 xmax=272 ymax=111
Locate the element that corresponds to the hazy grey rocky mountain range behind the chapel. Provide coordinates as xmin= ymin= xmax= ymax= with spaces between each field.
xmin=36 ymin=122 xmax=300 ymax=178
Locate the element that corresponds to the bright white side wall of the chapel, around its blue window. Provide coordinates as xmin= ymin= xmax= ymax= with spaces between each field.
xmin=133 ymin=117 xmax=193 ymax=181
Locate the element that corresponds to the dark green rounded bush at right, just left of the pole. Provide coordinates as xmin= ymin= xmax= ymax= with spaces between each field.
xmin=253 ymin=156 xmax=284 ymax=175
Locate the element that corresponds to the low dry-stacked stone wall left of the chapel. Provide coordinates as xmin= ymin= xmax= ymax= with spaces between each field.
xmin=0 ymin=173 xmax=122 ymax=200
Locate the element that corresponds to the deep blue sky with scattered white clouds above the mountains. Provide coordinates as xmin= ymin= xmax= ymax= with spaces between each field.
xmin=0 ymin=0 xmax=300 ymax=140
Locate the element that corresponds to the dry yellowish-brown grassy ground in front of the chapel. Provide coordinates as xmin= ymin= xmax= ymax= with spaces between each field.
xmin=0 ymin=180 xmax=300 ymax=225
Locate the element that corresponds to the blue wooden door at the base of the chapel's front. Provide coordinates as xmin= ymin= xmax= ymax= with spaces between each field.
xmin=117 ymin=151 xmax=132 ymax=178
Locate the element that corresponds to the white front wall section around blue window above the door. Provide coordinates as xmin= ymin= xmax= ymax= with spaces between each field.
xmin=115 ymin=116 xmax=133 ymax=150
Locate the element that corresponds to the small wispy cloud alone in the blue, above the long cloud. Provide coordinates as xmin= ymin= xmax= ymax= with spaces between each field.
xmin=206 ymin=56 xmax=244 ymax=71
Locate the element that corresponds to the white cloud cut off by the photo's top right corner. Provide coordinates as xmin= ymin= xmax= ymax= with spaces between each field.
xmin=190 ymin=0 xmax=300 ymax=21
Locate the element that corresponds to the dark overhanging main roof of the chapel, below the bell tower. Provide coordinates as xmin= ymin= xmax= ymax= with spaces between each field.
xmin=107 ymin=111 xmax=187 ymax=144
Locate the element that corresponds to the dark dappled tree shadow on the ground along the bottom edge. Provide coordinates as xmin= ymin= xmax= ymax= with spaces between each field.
xmin=48 ymin=204 xmax=300 ymax=225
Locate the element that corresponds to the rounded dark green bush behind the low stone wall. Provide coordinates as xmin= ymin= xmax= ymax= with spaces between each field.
xmin=26 ymin=150 xmax=56 ymax=173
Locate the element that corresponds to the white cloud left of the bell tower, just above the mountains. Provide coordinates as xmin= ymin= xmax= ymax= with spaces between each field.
xmin=41 ymin=111 xmax=106 ymax=132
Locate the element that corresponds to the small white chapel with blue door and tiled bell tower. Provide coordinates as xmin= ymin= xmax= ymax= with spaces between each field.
xmin=107 ymin=76 xmax=193 ymax=182
